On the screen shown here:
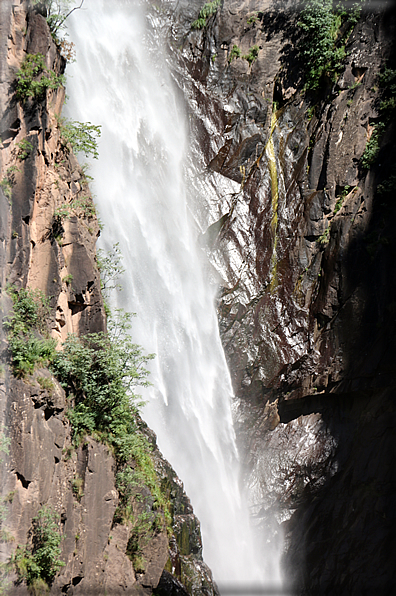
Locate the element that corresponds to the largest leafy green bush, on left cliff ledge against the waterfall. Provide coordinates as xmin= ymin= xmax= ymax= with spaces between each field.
xmin=52 ymin=311 xmax=153 ymax=461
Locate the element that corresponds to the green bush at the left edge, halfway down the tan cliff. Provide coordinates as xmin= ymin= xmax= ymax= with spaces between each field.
xmin=4 ymin=288 xmax=56 ymax=377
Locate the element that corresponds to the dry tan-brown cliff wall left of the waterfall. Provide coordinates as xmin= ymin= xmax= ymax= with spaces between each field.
xmin=0 ymin=0 xmax=217 ymax=596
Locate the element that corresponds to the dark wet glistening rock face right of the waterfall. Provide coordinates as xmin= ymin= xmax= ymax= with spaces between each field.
xmin=162 ymin=0 xmax=396 ymax=594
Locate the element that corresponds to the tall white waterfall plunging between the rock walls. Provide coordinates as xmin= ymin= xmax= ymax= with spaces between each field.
xmin=67 ymin=0 xmax=280 ymax=586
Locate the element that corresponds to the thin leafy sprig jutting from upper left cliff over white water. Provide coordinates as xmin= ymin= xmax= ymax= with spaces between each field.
xmin=58 ymin=118 xmax=101 ymax=159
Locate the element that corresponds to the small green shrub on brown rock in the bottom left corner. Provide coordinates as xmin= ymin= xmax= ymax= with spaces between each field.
xmin=13 ymin=506 xmax=64 ymax=592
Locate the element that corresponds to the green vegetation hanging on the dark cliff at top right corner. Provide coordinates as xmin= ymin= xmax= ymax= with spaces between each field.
xmin=297 ymin=0 xmax=360 ymax=90
